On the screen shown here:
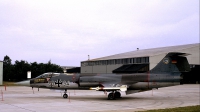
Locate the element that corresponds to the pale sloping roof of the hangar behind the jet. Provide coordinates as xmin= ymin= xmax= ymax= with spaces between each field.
xmin=87 ymin=43 xmax=200 ymax=61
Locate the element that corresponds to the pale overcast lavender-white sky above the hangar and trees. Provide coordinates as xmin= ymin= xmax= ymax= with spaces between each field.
xmin=0 ymin=0 xmax=199 ymax=66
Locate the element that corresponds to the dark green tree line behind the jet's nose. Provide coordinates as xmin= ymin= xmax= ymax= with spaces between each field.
xmin=3 ymin=55 xmax=63 ymax=81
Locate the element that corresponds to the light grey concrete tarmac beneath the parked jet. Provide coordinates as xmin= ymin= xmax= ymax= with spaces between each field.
xmin=0 ymin=84 xmax=200 ymax=112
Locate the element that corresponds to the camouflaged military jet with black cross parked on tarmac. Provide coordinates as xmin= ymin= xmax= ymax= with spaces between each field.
xmin=17 ymin=52 xmax=190 ymax=100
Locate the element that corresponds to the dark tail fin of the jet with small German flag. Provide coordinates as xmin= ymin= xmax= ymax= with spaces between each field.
xmin=150 ymin=52 xmax=190 ymax=73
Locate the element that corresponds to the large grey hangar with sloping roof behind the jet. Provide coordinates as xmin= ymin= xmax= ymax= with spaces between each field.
xmin=81 ymin=43 xmax=200 ymax=83
